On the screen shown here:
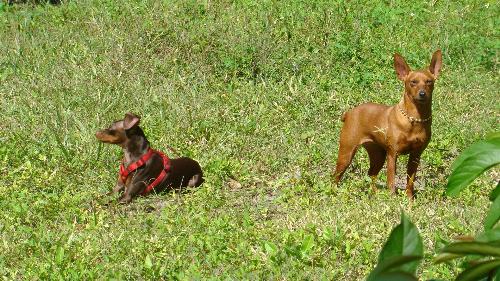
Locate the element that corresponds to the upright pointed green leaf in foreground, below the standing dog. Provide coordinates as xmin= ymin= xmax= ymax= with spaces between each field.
xmin=378 ymin=213 xmax=424 ymax=273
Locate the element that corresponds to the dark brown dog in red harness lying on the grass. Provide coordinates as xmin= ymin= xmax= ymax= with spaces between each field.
xmin=96 ymin=113 xmax=204 ymax=203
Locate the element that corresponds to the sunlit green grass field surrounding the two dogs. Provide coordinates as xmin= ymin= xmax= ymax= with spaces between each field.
xmin=0 ymin=0 xmax=500 ymax=280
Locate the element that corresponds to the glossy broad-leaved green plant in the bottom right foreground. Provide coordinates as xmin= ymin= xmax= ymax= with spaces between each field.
xmin=367 ymin=133 xmax=500 ymax=281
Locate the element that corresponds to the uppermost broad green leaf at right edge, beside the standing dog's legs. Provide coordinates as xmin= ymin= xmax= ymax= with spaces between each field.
xmin=446 ymin=138 xmax=500 ymax=196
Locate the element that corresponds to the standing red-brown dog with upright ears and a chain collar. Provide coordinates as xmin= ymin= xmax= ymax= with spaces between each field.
xmin=334 ymin=50 xmax=442 ymax=198
